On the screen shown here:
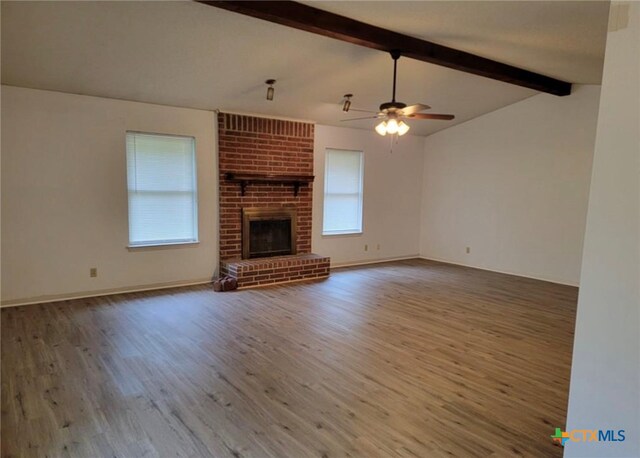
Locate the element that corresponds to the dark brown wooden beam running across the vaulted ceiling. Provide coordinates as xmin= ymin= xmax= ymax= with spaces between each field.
xmin=198 ymin=0 xmax=571 ymax=95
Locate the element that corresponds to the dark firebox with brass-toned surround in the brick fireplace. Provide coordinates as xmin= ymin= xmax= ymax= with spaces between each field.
xmin=242 ymin=208 xmax=297 ymax=259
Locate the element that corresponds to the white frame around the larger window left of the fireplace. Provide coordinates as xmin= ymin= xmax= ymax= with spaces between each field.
xmin=125 ymin=130 xmax=200 ymax=251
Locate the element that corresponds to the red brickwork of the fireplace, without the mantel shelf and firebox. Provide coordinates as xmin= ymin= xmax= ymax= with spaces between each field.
xmin=218 ymin=113 xmax=329 ymax=287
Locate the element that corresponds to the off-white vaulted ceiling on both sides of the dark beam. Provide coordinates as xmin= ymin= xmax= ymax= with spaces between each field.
xmin=2 ymin=1 xmax=608 ymax=135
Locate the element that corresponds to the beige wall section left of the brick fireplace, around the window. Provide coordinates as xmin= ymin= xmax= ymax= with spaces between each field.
xmin=2 ymin=86 xmax=218 ymax=305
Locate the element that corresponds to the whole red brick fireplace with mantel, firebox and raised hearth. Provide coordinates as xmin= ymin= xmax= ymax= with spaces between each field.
xmin=218 ymin=113 xmax=329 ymax=287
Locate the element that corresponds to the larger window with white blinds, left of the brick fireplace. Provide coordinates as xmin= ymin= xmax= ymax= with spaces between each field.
xmin=127 ymin=132 xmax=198 ymax=246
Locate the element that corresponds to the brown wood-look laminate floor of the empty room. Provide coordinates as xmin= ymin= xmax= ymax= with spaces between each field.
xmin=2 ymin=260 xmax=577 ymax=458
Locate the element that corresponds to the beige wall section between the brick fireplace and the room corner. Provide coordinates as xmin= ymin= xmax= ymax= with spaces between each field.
xmin=312 ymin=125 xmax=424 ymax=266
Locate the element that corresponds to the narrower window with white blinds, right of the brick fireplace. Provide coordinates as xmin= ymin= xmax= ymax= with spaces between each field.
xmin=322 ymin=149 xmax=363 ymax=235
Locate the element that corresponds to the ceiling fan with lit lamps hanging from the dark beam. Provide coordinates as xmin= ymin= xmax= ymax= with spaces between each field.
xmin=342 ymin=50 xmax=455 ymax=135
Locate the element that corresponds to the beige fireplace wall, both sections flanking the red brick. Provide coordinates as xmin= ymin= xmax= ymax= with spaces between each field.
xmin=2 ymin=86 xmax=424 ymax=305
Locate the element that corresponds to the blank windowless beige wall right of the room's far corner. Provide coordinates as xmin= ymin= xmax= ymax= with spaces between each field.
xmin=420 ymin=86 xmax=600 ymax=285
